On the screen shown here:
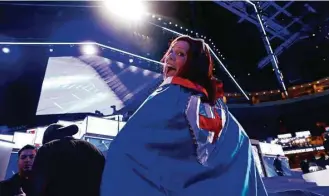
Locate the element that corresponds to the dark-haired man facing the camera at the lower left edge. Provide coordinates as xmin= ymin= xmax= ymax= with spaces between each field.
xmin=0 ymin=145 xmax=37 ymax=196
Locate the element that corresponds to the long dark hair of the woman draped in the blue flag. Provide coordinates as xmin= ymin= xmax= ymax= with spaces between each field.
xmin=161 ymin=35 xmax=216 ymax=105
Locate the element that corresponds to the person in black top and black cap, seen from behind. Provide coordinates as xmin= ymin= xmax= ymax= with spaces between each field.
xmin=32 ymin=124 xmax=105 ymax=196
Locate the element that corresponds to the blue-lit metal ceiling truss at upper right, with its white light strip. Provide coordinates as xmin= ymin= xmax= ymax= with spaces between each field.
xmin=215 ymin=0 xmax=317 ymax=95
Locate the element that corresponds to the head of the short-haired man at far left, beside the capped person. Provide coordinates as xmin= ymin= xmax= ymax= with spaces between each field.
xmin=18 ymin=145 xmax=37 ymax=175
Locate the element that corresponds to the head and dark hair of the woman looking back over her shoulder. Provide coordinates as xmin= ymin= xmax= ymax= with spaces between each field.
xmin=161 ymin=36 xmax=216 ymax=103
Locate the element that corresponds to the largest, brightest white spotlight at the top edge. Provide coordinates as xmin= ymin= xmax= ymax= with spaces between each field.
xmin=104 ymin=0 xmax=146 ymax=20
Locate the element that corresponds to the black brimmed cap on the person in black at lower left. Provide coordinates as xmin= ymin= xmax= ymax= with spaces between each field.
xmin=42 ymin=124 xmax=79 ymax=144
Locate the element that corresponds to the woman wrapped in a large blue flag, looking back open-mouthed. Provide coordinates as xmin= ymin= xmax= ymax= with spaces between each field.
xmin=101 ymin=36 xmax=266 ymax=196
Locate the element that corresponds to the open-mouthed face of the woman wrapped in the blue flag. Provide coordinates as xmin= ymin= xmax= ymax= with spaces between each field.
xmin=163 ymin=41 xmax=190 ymax=78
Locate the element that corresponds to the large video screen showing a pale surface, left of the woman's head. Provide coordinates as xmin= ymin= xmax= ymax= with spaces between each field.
xmin=37 ymin=56 xmax=162 ymax=115
